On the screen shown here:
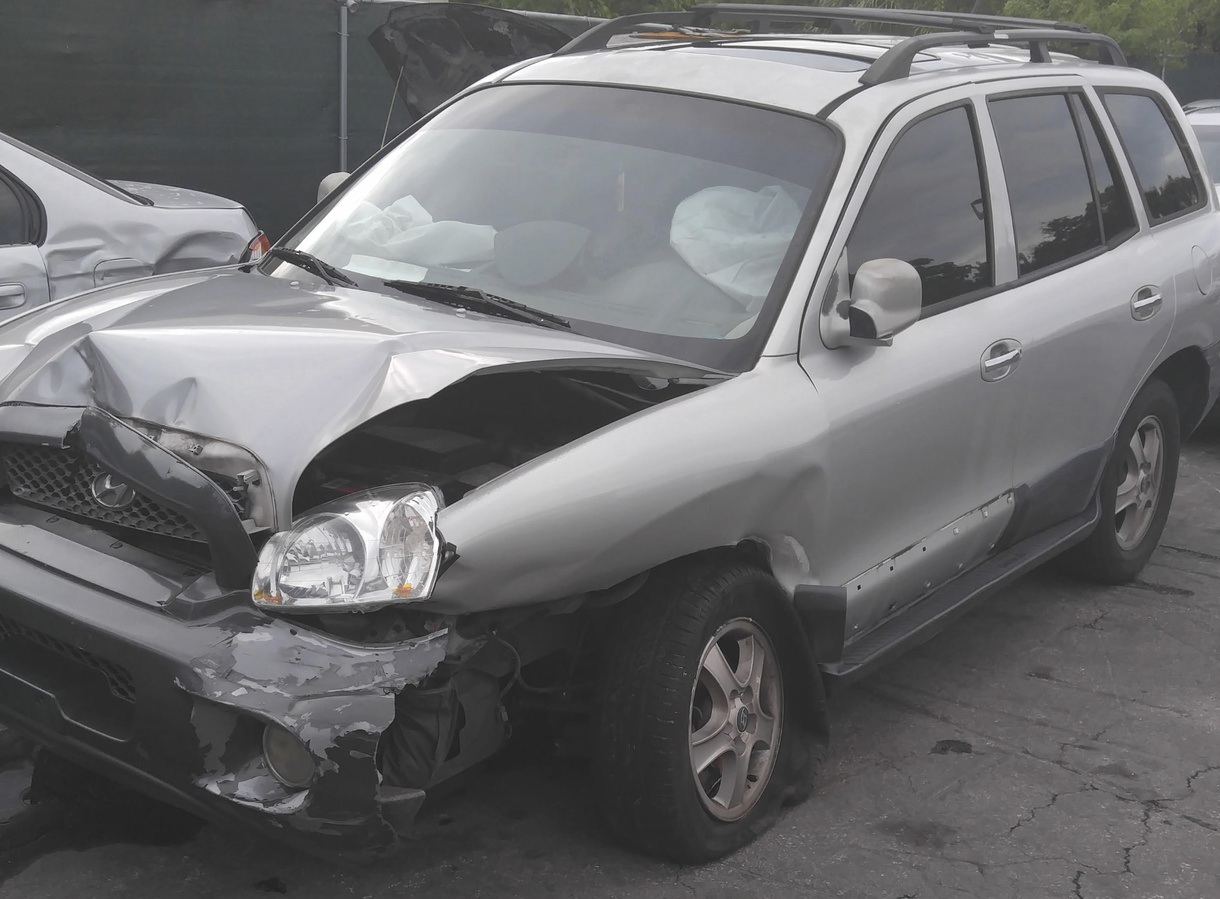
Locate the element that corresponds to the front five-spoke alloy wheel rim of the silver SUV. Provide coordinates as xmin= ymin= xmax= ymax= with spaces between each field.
xmin=689 ymin=618 xmax=783 ymax=821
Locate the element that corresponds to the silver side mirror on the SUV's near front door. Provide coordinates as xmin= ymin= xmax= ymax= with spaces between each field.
xmin=822 ymin=259 xmax=924 ymax=349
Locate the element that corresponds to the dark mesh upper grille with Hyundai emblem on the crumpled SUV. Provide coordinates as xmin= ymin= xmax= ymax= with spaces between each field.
xmin=2 ymin=443 xmax=204 ymax=540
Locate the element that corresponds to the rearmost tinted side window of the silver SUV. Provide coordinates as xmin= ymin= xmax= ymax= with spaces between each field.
xmin=1103 ymin=93 xmax=1204 ymax=222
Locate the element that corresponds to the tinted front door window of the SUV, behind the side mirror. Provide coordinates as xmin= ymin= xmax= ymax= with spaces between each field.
xmin=848 ymin=107 xmax=992 ymax=307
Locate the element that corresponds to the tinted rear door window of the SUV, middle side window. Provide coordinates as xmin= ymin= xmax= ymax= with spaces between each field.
xmin=989 ymin=94 xmax=1104 ymax=274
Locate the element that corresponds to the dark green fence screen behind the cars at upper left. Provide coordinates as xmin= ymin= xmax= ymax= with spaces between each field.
xmin=0 ymin=0 xmax=411 ymax=239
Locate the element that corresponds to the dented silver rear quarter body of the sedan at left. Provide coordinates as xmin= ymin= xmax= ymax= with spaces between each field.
xmin=0 ymin=135 xmax=257 ymax=317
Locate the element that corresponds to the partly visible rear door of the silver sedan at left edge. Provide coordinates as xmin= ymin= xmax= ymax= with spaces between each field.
xmin=0 ymin=168 xmax=50 ymax=320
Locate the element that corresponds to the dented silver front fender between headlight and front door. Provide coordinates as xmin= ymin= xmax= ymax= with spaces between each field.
xmin=428 ymin=359 xmax=826 ymax=614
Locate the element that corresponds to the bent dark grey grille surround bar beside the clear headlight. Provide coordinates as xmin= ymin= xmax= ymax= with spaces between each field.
xmin=68 ymin=406 xmax=257 ymax=589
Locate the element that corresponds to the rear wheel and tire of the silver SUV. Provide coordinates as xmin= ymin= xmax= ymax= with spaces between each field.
xmin=1065 ymin=379 xmax=1182 ymax=584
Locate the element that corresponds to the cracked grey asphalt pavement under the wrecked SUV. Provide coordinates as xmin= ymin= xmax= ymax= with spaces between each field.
xmin=0 ymin=431 xmax=1220 ymax=899
